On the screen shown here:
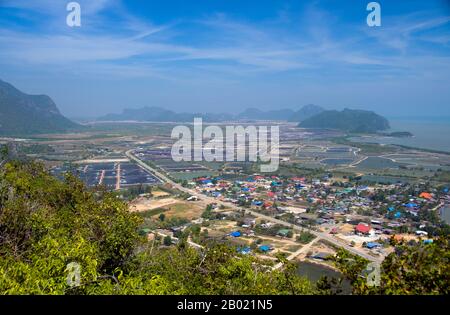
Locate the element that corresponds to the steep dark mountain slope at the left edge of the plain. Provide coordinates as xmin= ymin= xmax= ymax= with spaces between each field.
xmin=0 ymin=80 xmax=80 ymax=135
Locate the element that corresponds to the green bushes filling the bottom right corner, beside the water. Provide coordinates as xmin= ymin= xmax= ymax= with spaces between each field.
xmin=322 ymin=235 xmax=450 ymax=295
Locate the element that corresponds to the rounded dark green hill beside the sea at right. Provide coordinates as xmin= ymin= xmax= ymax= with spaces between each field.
xmin=299 ymin=108 xmax=390 ymax=133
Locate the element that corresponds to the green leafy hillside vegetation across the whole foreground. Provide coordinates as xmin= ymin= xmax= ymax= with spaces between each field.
xmin=0 ymin=161 xmax=450 ymax=294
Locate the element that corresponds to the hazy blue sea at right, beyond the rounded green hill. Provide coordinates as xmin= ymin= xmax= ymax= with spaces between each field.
xmin=353 ymin=117 xmax=450 ymax=152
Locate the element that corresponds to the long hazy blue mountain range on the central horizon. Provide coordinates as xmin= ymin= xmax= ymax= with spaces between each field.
xmin=97 ymin=105 xmax=324 ymax=122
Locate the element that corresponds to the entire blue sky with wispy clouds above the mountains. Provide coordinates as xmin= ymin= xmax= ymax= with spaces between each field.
xmin=0 ymin=0 xmax=450 ymax=117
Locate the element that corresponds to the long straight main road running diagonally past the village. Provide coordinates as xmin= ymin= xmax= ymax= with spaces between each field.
xmin=125 ymin=150 xmax=383 ymax=263
